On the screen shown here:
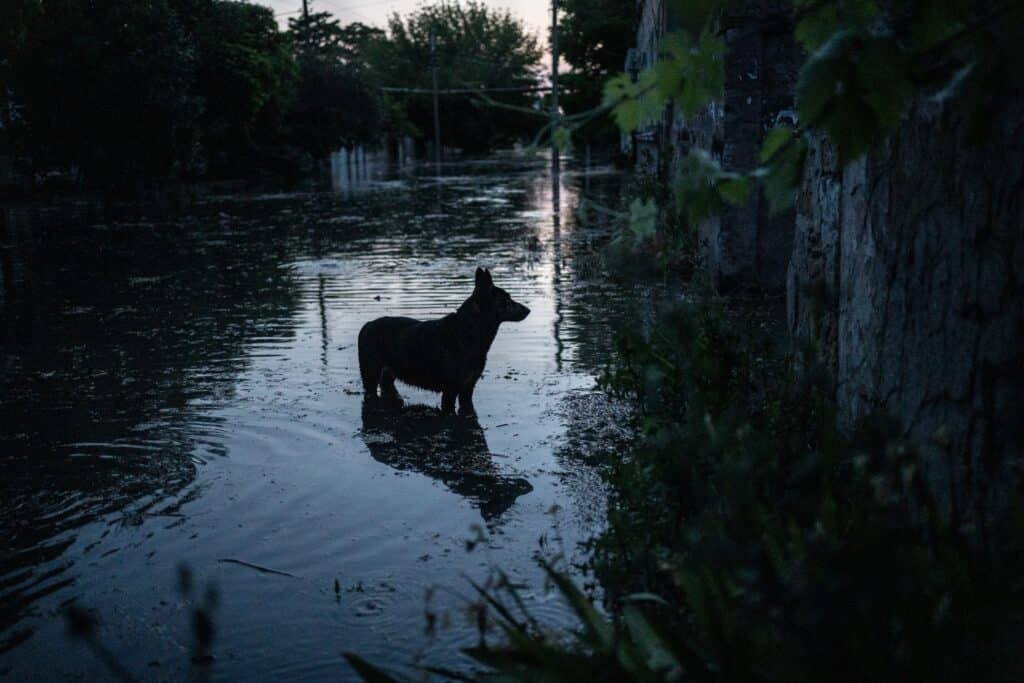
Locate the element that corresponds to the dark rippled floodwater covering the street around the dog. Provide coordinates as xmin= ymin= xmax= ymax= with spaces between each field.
xmin=0 ymin=156 xmax=638 ymax=680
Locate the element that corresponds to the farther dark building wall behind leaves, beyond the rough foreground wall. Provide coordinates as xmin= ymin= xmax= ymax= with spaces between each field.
xmin=636 ymin=0 xmax=799 ymax=290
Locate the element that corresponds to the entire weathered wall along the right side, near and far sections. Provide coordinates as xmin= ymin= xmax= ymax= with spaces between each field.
xmin=640 ymin=0 xmax=1024 ymax=516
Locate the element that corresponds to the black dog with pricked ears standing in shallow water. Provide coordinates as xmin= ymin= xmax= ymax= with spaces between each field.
xmin=359 ymin=268 xmax=529 ymax=413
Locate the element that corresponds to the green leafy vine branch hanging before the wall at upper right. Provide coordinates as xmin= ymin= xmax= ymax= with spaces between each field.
xmin=605 ymin=0 xmax=1022 ymax=246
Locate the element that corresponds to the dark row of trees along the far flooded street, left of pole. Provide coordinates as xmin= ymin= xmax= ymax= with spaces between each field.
xmin=0 ymin=0 xmax=541 ymax=183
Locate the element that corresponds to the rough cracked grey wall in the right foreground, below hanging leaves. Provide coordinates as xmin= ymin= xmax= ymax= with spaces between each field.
xmin=787 ymin=96 xmax=1024 ymax=508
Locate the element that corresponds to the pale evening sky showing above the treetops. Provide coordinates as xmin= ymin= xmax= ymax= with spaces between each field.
xmin=255 ymin=0 xmax=551 ymax=38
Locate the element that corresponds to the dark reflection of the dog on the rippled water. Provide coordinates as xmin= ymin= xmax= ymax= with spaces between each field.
xmin=362 ymin=398 xmax=534 ymax=521
